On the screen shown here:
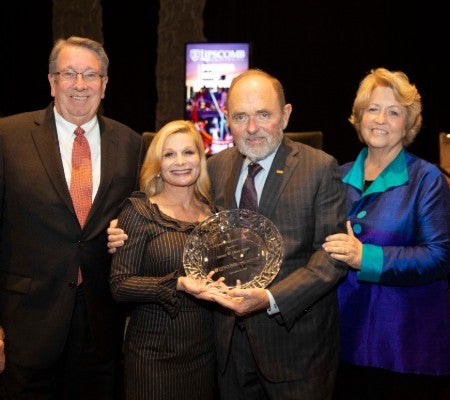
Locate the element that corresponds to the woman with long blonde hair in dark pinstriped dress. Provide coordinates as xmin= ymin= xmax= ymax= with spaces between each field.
xmin=110 ymin=120 xmax=215 ymax=400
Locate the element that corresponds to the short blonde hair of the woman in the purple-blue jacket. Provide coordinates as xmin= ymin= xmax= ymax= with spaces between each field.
xmin=348 ymin=68 xmax=422 ymax=146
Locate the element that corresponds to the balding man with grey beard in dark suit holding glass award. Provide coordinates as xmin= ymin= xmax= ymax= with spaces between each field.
xmin=108 ymin=70 xmax=348 ymax=400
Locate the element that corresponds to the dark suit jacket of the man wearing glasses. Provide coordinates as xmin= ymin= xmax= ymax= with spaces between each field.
xmin=0 ymin=104 xmax=143 ymax=368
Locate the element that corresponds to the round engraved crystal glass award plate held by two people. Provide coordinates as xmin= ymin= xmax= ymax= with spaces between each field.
xmin=183 ymin=209 xmax=283 ymax=288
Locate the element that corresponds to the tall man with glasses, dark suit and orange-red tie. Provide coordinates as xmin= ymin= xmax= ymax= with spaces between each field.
xmin=0 ymin=37 xmax=143 ymax=400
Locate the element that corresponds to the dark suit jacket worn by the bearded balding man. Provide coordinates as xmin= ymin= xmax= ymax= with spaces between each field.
xmin=208 ymin=138 xmax=347 ymax=382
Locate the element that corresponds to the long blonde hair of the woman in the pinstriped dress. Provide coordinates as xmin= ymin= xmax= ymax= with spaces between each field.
xmin=140 ymin=120 xmax=212 ymax=204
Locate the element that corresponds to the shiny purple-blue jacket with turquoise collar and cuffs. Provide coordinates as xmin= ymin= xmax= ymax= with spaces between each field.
xmin=338 ymin=149 xmax=450 ymax=375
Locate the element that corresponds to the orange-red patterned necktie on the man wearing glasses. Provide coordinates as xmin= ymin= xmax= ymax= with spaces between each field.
xmin=70 ymin=126 xmax=92 ymax=285
